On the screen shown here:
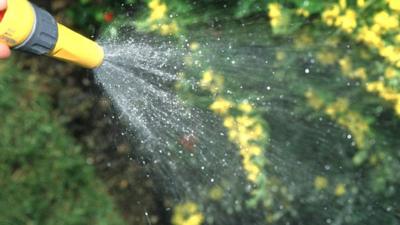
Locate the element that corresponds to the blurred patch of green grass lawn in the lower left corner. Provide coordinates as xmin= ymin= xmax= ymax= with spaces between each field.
xmin=0 ymin=63 xmax=123 ymax=225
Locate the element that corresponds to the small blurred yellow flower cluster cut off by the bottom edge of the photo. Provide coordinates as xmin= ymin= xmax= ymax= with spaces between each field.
xmin=172 ymin=202 xmax=204 ymax=225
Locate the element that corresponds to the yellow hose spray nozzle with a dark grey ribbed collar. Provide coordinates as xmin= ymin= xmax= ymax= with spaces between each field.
xmin=0 ymin=0 xmax=104 ymax=69
